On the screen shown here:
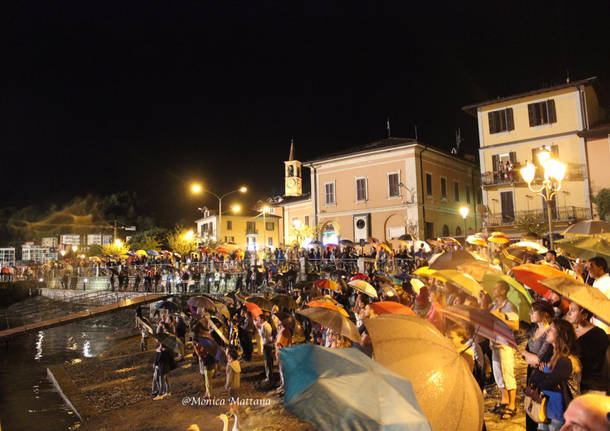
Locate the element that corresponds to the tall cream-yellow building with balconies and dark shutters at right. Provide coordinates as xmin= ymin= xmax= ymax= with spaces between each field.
xmin=462 ymin=78 xmax=608 ymax=235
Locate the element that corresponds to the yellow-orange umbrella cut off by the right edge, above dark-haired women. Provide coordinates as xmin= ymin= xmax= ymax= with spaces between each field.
xmin=540 ymin=277 xmax=610 ymax=324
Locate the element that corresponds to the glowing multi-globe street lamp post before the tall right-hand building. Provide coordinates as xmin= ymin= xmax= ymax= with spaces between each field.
xmin=520 ymin=150 xmax=566 ymax=250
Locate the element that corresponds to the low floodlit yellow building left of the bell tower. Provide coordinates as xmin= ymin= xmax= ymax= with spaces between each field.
xmin=195 ymin=208 xmax=281 ymax=250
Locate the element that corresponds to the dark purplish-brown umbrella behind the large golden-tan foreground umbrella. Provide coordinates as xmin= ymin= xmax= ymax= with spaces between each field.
xmin=441 ymin=305 xmax=517 ymax=349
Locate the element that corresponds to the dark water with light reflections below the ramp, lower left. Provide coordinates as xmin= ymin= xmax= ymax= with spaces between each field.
xmin=0 ymin=300 xmax=128 ymax=431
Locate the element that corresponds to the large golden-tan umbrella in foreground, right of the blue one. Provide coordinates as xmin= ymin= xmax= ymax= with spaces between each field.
xmin=364 ymin=314 xmax=483 ymax=431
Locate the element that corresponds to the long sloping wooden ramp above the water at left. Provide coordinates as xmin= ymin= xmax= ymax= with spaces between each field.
xmin=0 ymin=294 xmax=171 ymax=339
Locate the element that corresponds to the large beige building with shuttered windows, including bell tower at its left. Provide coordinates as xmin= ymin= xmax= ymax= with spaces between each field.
xmin=275 ymin=138 xmax=480 ymax=244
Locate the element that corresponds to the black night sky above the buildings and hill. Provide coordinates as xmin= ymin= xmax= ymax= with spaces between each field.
xmin=0 ymin=0 xmax=610 ymax=226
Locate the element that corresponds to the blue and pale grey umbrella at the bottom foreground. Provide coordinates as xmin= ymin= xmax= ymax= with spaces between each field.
xmin=280 ymin=344 xmax=431 ymax=431
